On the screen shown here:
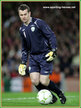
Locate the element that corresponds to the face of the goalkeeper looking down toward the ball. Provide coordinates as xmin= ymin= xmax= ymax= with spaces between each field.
xmin=19 ymin=9 xmax=31 ymax=23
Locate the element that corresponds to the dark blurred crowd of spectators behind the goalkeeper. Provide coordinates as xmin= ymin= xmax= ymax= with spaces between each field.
xmin=2 ymin=2 xmax=79 ymax=88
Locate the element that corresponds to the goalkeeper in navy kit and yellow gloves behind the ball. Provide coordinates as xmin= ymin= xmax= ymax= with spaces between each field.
xmin=18 ymin=4 xmax=66 ymax=104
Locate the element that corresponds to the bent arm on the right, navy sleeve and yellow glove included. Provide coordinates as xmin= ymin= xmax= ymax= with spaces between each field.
xmin=37 ymin=20 xmax=57 ymax=62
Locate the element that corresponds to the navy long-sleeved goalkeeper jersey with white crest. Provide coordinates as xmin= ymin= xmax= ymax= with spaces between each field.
xmin=19 ymin=18 xmax=57 ymax=63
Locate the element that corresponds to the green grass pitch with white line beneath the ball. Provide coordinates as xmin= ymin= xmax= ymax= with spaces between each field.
xmin=2 ymin=92 xmax=79 ymax=107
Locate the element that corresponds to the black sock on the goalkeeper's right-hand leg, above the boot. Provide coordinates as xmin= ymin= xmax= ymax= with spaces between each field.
xmin=48 ymin=80 xmax=62 ymax=95
